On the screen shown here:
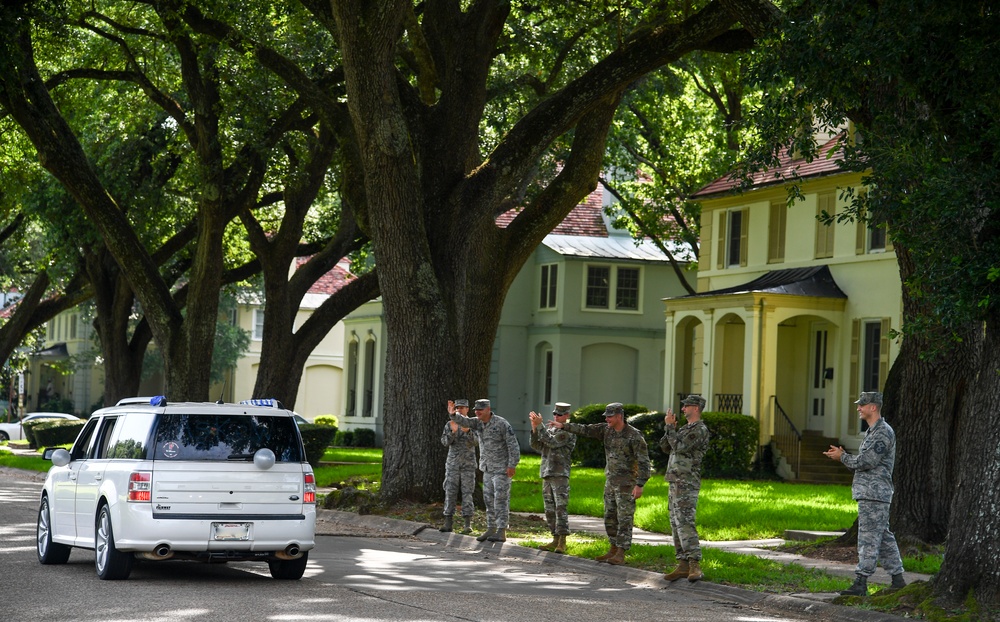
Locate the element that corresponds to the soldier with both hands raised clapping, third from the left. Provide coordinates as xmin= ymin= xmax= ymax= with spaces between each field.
xmin=528 ymin=402 xmax=576 ymax=553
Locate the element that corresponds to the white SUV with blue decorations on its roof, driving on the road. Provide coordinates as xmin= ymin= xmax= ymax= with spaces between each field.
xmin=37 ymin=396 xmax=316 ymax=580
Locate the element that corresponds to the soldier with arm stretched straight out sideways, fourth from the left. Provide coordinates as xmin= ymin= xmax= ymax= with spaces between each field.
xmin=552 ymin=402 xmax=649 ymax=565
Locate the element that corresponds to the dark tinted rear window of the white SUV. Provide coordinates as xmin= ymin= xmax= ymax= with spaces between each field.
xmin=153 ymin=414 xmax=303 ymax=462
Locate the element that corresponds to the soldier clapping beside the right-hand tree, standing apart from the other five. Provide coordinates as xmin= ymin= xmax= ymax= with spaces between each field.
xmin=823 ymin=391 xmax=906 ymax=596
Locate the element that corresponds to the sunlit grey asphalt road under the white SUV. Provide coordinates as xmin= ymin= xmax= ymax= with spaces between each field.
xmin=0 ymin=470 xmax=897 ymax=622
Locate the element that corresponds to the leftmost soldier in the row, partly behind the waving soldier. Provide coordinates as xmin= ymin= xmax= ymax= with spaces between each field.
xmin=440 ymin=400 xmax=476 ymax=533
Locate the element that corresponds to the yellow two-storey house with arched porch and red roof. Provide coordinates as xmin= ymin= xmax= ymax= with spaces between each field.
xmin=664 ymin=141 xmax=902 ymax=481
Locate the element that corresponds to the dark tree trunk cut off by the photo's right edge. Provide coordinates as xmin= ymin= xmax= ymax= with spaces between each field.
xmin=934 ymin=316 xmax=1000 ymax=610
